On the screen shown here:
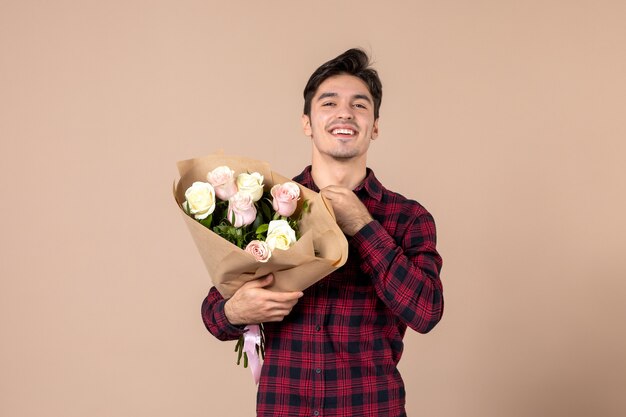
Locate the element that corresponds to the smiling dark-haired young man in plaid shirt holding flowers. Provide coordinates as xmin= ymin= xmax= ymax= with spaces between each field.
xmin=202 ymin=49 xmax=443 ymax=417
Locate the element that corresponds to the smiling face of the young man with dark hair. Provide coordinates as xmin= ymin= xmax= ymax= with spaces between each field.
xmin=302 ymin=74 xmax=378 ymax=162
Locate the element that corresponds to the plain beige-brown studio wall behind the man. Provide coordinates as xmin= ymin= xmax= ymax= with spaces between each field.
xmin=0 ymin=0 xmax=626 ymax=417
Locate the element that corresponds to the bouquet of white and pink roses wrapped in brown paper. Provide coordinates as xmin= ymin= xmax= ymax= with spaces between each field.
xmin=174 ymin=154 xmax=348 ymax=382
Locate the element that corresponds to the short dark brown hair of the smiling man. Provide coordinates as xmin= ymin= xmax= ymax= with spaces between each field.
xmin=304 ymin=48 xmax=383 ymax=119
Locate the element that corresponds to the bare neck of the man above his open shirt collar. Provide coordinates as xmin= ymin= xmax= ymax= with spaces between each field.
xmin=311 ymin=154 xmax=367 ymax=190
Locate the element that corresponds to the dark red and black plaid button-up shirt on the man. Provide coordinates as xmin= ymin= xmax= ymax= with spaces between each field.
xmin=202 ymin=167 xmax=443 ymax=417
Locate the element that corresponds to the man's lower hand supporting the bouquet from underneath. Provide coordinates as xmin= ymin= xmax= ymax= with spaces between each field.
xmin=224 ymin=274 xmax=303 ymax=325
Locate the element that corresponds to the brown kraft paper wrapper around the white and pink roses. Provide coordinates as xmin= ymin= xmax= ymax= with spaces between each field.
xmin=174 ymin=154 xmax=348 ymax=298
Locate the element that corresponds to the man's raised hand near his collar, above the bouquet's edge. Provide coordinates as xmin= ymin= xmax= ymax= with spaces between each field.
xmin=320 ymin=185 xmax=374 ymax=236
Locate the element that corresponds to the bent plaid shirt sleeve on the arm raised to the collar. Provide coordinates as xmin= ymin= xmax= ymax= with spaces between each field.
xmin=352 ymin=212 xmax=443 ymax=333
